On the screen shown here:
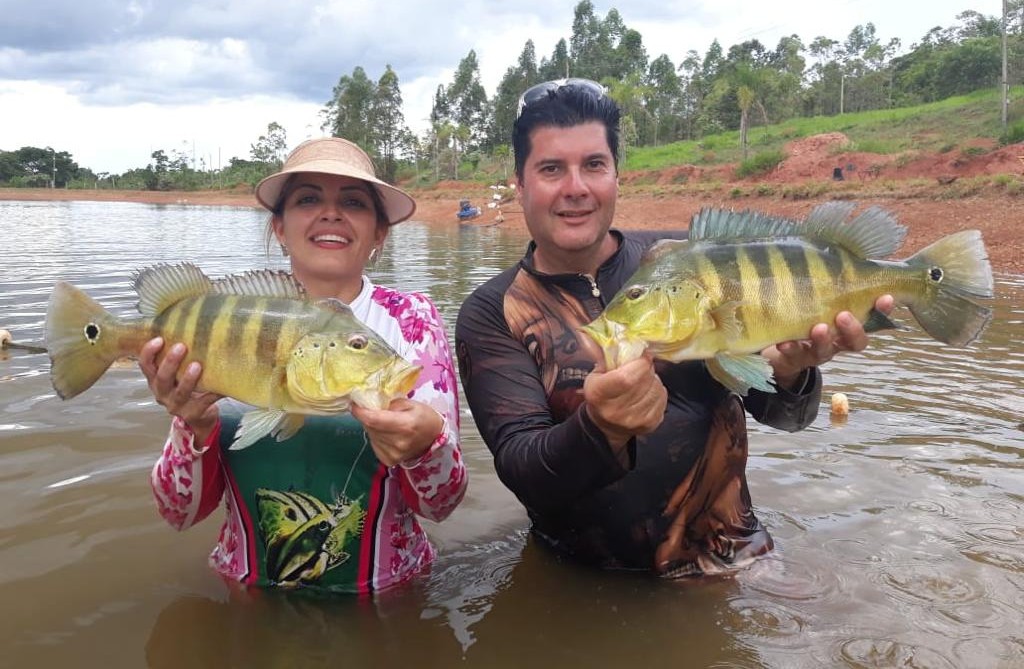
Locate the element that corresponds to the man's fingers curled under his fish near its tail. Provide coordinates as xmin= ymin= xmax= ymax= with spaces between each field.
xmin=762 ymin=295 xmax=894 ymax=389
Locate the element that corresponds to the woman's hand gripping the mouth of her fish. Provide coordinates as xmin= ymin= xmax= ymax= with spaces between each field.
xmin=352 ymin=398 xmax=444 ymax=467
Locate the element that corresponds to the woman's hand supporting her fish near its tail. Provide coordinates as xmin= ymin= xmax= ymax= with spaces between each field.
xmin=138 ymin=337 xmax=221 ymax=445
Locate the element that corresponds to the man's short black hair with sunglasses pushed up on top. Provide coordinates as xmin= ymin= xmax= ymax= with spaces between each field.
xmin=512 ymin=79 xmax=621 ymax=180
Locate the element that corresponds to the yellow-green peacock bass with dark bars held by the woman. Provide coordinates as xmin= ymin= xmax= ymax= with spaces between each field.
xmin=44 ymin=263 xmax=421 ymax=449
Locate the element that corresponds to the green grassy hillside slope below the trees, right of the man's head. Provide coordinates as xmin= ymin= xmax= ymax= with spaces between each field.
xmin=622 ymin=87 xmax=1024 ymax=171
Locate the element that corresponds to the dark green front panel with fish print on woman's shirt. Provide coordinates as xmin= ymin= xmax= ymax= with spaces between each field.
xmin=220 ymin=406 xmax=387 ymax=592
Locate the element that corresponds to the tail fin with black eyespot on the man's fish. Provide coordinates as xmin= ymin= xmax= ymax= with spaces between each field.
xmin=906 ymin=229 xmax=993 ymax=346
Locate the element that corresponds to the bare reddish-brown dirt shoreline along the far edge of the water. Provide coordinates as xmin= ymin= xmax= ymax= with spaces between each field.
xmin=0 ymin=182 xmax=1024 ymax=275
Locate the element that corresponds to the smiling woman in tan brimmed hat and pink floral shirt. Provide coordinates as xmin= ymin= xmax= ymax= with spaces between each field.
xmin=139 ymin=137 xmax=466 ymax=592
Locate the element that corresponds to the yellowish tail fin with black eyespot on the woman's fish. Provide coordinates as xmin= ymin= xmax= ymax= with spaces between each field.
xmin=45 ymin=281 xmax=121 ymax=400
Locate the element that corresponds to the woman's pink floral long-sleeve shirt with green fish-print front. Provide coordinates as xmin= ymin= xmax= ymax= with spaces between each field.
xmin=152 ymin=278 xmax=467 ymax=592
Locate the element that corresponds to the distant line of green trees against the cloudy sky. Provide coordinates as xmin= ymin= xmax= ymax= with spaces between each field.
xmin=0 ymin=0 xmax=1024 ymax=190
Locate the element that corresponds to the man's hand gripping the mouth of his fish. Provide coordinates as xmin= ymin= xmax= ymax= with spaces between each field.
xmin=583 ymin=356 xmax=669 ymax=450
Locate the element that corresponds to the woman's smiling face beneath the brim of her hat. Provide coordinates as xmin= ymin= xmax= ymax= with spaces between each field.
xmin=273 ymin=173 xmax=387 ymax=296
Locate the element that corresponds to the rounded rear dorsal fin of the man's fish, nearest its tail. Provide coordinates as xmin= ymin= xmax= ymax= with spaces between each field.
xmin=805 ymin=202 xmax=906 ymax=258
